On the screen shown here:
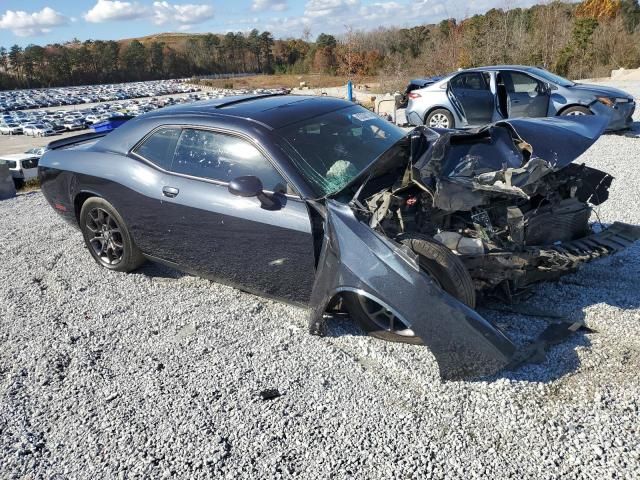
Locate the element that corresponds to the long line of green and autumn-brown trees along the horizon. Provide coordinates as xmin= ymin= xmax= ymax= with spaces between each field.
xmin=0 ymin=0 xmax=640 ymax=89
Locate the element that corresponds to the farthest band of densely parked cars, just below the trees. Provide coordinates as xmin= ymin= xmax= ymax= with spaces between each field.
xmin=0 ymin=80 xmax=198 ymax=112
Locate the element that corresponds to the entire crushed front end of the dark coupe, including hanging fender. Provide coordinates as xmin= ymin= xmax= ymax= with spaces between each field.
xmin=312 ymin=117 xmax=640 ymax=379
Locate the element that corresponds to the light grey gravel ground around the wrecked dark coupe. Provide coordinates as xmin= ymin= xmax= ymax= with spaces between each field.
xmin=0 ymin=124 xmax=640 ymax=479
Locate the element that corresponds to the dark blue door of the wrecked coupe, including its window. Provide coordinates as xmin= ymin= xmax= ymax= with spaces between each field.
xmin=158 ymin=128 xmax=315 ymax=304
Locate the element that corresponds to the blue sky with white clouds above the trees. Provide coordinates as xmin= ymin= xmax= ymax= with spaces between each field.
xmin=0 ymin=0 xmax=552 ymax=47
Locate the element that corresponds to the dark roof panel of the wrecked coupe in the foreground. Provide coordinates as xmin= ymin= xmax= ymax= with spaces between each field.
xmin=140 ymin=94 xmax=354 ymax=129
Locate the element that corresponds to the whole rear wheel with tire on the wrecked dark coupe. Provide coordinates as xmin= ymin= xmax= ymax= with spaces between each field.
xmin=80 ymin=197 xmax=144 ymax=272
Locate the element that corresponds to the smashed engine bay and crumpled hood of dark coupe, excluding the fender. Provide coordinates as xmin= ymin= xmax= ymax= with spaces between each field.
xmin=352 ymin=119 xmax=639 ymax=298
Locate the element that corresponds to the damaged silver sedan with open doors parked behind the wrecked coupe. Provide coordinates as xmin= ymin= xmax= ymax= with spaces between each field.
xmin=406 ymin=65 xmax=635 ymax=130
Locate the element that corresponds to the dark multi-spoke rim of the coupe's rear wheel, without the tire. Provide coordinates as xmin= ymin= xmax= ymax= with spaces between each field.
xmin=85 ymin=208 xmax=124 ymax=267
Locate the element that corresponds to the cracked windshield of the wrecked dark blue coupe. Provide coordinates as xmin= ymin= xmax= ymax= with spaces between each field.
xmin=278 ymin=105 xmax=406 ymax=197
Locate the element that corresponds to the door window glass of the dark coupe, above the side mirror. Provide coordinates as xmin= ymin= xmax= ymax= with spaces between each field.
xmin=171 ymin=128 xmax=287 ymax=193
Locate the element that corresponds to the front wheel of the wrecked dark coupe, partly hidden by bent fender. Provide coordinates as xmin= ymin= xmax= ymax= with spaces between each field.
xmin=343 ymin=234 xmax=476 ymax=345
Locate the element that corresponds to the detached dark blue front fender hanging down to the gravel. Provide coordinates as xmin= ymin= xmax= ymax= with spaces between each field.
xmin=311 ymin=200 xmax=515 ymax=380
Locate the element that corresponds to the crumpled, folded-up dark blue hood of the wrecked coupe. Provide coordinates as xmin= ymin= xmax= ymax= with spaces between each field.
xmin=411 ymin=116 xmax=607 ymax=211
